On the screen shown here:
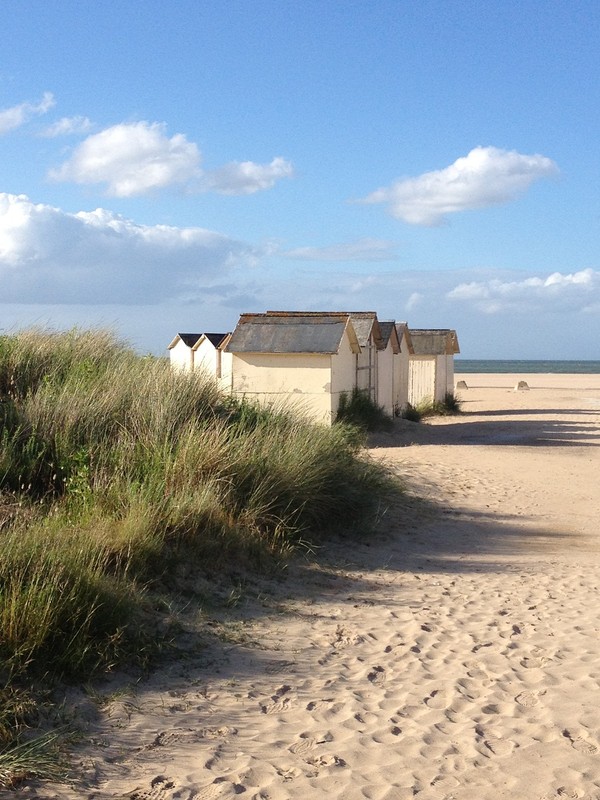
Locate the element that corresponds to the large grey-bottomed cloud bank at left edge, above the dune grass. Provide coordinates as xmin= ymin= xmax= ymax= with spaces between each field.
xmin=0 ymin=193 xmax=262 ymax=305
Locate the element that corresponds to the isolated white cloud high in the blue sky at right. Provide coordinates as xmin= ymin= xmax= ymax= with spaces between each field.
xmin=363 ymin=147 xmax=558 ymax=226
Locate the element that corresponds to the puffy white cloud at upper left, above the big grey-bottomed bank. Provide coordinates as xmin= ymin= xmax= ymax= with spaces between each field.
xmin=50 ymin=122 xmax=200 ymax=197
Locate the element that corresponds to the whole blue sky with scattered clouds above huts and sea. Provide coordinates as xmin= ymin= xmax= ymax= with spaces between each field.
xmin=0 ymin=0 xmax=600 ymax=359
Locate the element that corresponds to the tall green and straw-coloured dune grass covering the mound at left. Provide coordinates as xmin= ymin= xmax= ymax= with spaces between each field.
xmin=0 ymin=330 xmax=395 ymax=785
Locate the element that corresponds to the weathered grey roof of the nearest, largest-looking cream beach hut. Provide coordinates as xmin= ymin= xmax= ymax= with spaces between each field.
xmin=225 ymin=312 xmax=355 ymax=354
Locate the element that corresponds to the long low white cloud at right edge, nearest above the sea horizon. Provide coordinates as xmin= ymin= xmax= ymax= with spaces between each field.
xmin=447 ymin=269 xmax=600 ymax=314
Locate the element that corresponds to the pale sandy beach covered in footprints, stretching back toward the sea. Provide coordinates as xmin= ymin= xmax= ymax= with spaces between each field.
xmin=19 ymin=374 xmax=600 ymax=800
